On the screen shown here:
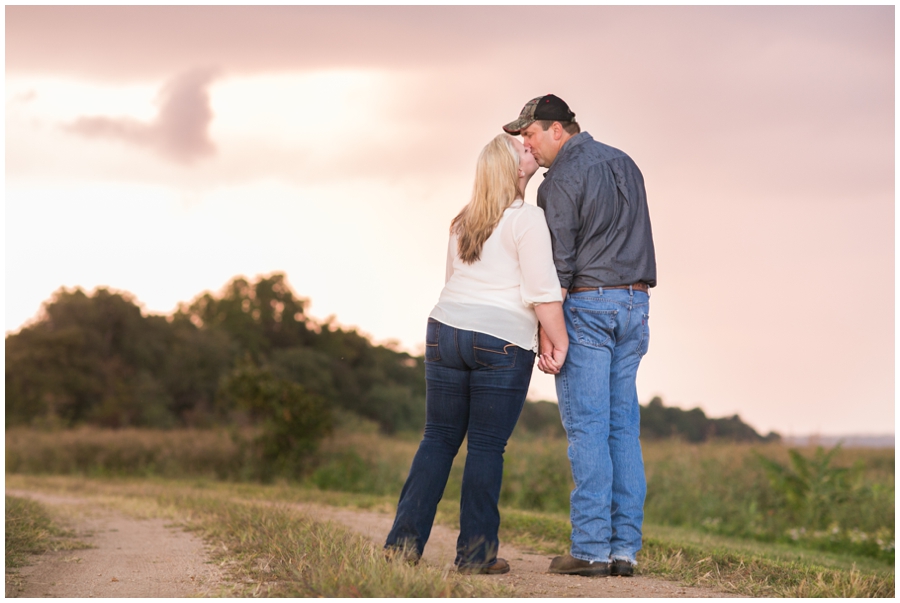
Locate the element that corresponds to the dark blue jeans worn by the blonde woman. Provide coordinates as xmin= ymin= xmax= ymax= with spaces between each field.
xmin=385 ymin=318 xmax=534 ymax=565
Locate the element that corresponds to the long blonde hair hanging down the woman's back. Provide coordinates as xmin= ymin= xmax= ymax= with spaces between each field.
xmin=450 ymin=134 xmax=522 ymax=264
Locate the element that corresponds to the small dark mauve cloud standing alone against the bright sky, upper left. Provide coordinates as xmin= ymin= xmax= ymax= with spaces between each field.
xmin=64 ymin=68 xmax=217 ymax=164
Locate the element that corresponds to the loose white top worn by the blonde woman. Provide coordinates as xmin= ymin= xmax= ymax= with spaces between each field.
xmin=430 ymin=199 xmax=562 ymax=350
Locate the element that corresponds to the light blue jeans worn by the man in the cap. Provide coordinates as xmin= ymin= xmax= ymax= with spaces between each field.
xmin=556 ymin=289 xmax=650 ymax=562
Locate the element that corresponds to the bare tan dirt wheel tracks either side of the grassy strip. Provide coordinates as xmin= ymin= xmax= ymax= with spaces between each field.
xmin=6 ymin=490 xmax=735 ymax=598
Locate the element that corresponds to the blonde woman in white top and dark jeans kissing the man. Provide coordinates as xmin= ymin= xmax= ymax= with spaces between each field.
xmin=385 ymin=134 xmax=569 ymax=574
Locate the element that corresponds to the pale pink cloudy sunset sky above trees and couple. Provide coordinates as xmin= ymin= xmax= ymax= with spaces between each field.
xmin=5 ymin=5 xmax=895 ymax=435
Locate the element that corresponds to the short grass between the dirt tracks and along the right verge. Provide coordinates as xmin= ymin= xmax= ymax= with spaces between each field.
xmin=7 ymin=476 xmax=894 ymax=597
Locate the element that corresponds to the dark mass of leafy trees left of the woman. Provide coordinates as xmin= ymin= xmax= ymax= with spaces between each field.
xmin=6 ymin=273 xmax=425 ymax=433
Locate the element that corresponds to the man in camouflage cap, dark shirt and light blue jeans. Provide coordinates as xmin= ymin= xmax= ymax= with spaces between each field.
xmin=503 ymin=94 xmax=656 ymax=576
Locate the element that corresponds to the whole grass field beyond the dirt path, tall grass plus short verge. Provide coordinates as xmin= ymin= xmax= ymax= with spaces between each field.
xmin=6 ymin=430 xmax=894 ymax=596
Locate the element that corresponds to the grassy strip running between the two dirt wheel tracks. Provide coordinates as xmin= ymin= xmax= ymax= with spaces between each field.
xmin=7 ymin=476 xmax=515 ymax=597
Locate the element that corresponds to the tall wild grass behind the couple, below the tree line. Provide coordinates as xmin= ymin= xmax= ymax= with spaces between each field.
xmin=6 ymin=429 xmax=894 ymax=564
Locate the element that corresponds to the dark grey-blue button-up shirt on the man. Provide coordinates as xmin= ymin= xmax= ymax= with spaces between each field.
xmin=537 ymin=132 xmax=656 ymax=289
